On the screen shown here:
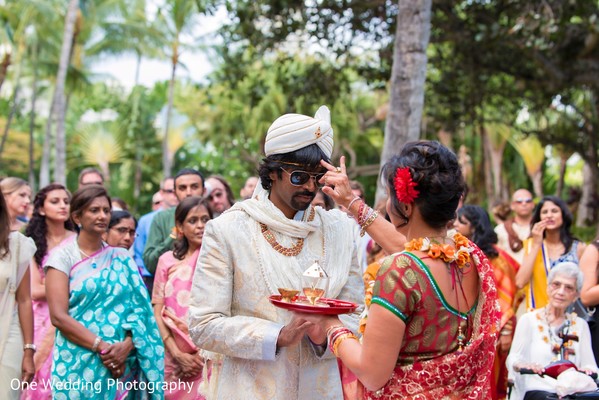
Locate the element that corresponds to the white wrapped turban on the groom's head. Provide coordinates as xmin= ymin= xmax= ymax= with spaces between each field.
xmin=264 ymin=106 xmax=333 ymax=158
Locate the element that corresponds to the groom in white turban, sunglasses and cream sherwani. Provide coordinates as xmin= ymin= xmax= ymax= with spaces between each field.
xmin=189 ymin=106 xmax=363 ymax=399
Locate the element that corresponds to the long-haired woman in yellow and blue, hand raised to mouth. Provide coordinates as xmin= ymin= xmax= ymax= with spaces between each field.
xmin=516 ymin=196 xmax=585 ymax=308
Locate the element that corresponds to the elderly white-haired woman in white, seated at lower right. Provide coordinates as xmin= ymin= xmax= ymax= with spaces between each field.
xmin=506 ymin=262 xmax=597 ymax=400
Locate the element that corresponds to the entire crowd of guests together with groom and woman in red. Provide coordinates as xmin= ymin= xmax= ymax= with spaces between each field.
xmin=0 ymin=106 xmax=599 ymax=400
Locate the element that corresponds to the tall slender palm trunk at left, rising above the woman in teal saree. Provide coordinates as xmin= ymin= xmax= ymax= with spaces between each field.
xmin=54 ymin=0 xmax=79 ymax=185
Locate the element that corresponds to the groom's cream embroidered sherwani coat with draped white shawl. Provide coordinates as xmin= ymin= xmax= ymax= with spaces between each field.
xmin=189 ymin=194 xmax=363 ymax=400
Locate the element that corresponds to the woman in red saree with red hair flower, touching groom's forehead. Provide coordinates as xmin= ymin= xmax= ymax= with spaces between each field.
xmin=302 ymin=141 xmax=499 ymax=400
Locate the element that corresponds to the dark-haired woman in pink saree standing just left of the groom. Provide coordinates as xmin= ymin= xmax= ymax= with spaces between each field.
xmin=152 ymin=197 xmax=212 ymax=400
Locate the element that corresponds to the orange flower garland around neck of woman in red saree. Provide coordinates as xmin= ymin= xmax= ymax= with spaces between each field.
xmin=405 ymin=232 xmax=474 ymax=269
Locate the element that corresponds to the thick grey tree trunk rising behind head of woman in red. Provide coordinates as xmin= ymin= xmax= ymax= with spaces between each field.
xmin=376 ymin=0 xmax=432 ymax=201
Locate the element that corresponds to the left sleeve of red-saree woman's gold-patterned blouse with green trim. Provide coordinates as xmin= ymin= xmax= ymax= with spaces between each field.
xmin=372 ymin=254 xmax=422 ymax=322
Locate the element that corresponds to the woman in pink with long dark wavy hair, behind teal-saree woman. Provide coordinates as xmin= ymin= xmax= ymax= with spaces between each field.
xmin=21 ymin=183 xmax=75 ymax=400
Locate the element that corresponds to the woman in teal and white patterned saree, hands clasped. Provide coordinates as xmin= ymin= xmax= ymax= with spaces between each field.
xmin=44 ymin=185 xmax=164 ymax=399
